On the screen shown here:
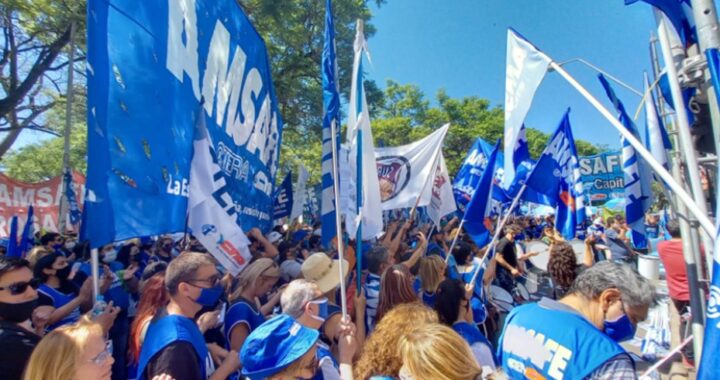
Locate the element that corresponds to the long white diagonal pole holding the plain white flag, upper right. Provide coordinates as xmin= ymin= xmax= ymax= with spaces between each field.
xmin=550 ymin=61 xmax=715 ymax=240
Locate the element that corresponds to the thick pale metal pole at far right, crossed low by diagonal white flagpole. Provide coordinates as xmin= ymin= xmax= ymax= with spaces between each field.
xmin=655 ymin=10 xmax=714 ymax=274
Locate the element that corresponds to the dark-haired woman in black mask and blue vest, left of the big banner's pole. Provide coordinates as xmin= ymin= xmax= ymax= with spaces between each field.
xmin=33 ymin=253 xmax=93 ymax=330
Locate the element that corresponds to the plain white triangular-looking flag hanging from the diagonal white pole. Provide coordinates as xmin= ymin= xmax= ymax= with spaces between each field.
xmin=503 ymin=29 xmax=551 ymax=188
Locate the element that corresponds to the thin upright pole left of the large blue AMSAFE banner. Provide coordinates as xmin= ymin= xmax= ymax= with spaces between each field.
xmin=58 ymin=21 xmax=75 ymax=234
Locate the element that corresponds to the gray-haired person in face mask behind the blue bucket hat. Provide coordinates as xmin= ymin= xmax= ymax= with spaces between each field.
xmin=280 ymin=279 xmax=364 ymax=380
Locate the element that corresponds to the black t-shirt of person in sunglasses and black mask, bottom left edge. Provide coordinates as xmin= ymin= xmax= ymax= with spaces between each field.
xmin=0 ymin=321 xmax=40 ymax=380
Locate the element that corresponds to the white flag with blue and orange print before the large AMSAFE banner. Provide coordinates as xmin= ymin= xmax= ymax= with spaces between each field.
xmin=188 ymin=111 xmax=251 ymax=276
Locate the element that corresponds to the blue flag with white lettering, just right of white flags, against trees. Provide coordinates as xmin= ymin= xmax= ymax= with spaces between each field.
xmin=453 ymin=138 xmax=507 ymax=211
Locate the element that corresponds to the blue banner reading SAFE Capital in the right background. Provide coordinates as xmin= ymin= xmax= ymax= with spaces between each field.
xmin=580 ymin=151 xmax=625 ymax=204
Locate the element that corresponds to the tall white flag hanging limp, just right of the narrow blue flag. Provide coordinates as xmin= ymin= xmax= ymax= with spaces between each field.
xmin=345 ymin=22 xmax=383 ymax=240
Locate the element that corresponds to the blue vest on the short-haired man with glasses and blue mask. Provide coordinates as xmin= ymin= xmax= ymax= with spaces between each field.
xmin=137 ymin=315 xmax=212 ymax=380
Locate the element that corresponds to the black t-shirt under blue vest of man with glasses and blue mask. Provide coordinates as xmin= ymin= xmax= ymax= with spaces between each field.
xmin=145 ymin=341 xmax=204 ymax=380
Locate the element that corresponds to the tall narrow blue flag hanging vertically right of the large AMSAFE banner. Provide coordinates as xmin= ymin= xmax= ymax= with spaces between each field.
xmin=320 ymin=0 xmax=340 ymax=247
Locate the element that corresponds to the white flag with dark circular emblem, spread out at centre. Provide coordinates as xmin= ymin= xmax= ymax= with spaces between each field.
xmin=375 ymin=124 xmax=450 ymax=210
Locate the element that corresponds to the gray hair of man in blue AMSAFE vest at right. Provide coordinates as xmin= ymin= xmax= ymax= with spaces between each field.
xmin=570 ymin=261 xmax=656 ymax=307
